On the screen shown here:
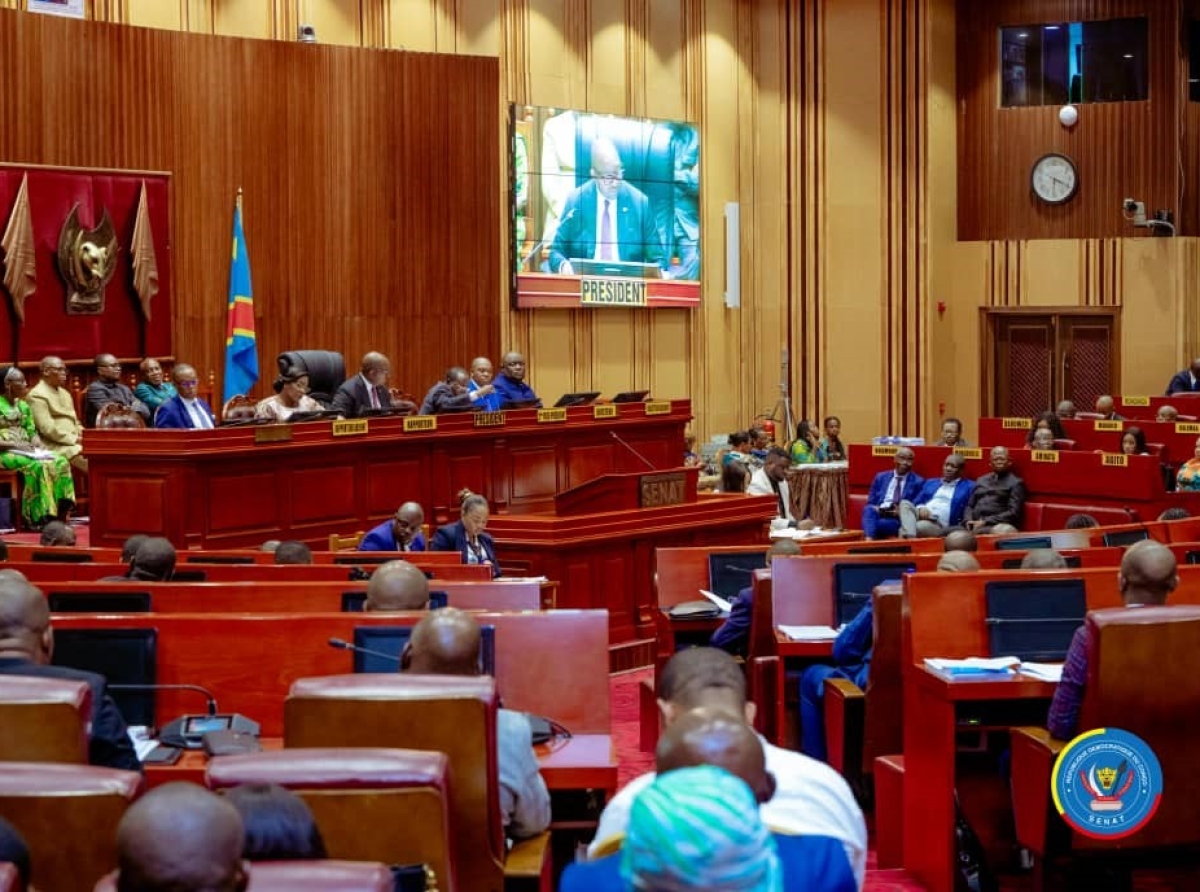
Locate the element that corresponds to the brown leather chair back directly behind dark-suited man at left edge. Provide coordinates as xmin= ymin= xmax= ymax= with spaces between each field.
xmin=0 ymin=675 xmax=91 ymax=771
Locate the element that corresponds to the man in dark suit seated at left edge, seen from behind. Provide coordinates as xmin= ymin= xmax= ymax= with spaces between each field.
xmin=0 ymin=576 xmax=142 ymax=771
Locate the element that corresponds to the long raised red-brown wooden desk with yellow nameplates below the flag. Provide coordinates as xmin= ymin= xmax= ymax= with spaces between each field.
xmin=85 ymin=400 xmax=691 ymax=552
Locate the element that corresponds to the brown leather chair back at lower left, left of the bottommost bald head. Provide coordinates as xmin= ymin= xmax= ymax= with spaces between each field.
xmin=0 ymin=762 xmax=143 ymax=892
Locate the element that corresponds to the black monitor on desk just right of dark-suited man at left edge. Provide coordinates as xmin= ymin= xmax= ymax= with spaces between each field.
xmin=53 ymin=629 xmax=158 ymax=726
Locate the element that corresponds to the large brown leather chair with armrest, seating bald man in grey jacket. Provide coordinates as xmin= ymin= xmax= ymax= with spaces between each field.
xmin=283 ymin=674 xmax=550 ymax=892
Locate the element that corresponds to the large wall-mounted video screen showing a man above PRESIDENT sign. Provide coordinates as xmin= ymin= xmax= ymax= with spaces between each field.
xmin=509 ymin=106 xmax=701 ymax=309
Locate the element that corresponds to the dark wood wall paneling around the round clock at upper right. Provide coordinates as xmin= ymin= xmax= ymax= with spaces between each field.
xmin=956 ymin=0 xmax=1182 ymax=240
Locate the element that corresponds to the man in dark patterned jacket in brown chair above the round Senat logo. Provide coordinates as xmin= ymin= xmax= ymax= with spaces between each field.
xmin=1046 ymin=539 xmax=1180 ymax=741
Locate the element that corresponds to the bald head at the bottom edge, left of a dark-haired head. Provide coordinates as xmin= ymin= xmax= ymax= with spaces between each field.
xmin=116 ymin=783 xmax=250 ymax=892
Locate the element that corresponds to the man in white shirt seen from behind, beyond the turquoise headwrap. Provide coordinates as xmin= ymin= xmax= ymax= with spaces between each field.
xmin=588 ymin=647 xmax=866 ymax=888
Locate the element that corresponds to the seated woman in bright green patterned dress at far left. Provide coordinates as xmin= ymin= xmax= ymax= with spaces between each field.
xmin=0 ymin=366 xmax=74 ymax=528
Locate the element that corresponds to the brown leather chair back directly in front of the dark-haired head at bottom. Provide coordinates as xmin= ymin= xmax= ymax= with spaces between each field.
xmin=205 ymin=747 xmax=455 ymax=890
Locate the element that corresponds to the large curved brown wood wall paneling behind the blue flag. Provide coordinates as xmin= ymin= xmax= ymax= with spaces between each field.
xmin=0 ymin=12 xmax=500 ymax=393
